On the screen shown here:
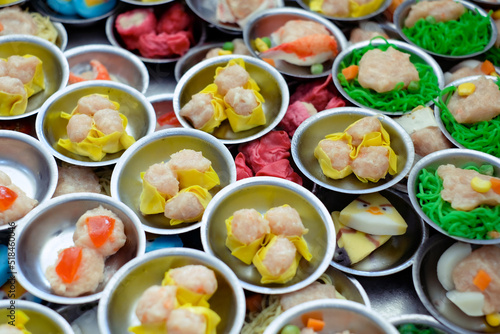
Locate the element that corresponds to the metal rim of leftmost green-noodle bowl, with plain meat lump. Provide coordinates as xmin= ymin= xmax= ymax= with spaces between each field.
xmin=332 ymin=39 xmax=444 ymax=116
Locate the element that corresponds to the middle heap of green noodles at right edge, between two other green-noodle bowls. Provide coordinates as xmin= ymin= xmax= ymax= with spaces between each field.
xmin=436 ymin=81 xmax=500 ymax=158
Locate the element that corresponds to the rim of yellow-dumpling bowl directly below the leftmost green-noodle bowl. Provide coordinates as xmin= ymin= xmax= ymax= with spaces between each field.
xmin=291 ymin=107 xmax=415 ymax=195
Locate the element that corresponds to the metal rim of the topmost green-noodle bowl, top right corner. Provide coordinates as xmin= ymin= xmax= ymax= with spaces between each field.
xmin=394 ymin=0 xmax=498 ymax=60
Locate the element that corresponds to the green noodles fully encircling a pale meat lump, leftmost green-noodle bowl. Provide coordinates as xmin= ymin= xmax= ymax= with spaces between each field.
xmin=337 ymin=39 xmax=439 ymax=112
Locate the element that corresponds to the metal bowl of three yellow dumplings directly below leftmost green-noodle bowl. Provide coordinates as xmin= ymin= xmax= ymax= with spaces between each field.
xmin=291 ymin=107 xmax=415 ymax=194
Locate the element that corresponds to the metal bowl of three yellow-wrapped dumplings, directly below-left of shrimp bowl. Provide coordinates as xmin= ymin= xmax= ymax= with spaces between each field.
xmin=174 ymin=55 xmax=290 ymax=144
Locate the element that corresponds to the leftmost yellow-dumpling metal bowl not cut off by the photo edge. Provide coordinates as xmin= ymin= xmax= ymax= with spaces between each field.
xmin=35 ymin=80 xmax=156 ymax=167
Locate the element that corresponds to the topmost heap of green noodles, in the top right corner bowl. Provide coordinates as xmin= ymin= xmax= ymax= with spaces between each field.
xmin=402 ymin=10 xmax=491 ymax=56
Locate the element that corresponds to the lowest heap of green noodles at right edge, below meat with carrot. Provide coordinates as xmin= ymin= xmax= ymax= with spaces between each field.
xmin=416 ymin=166 xmax=500 ymax=240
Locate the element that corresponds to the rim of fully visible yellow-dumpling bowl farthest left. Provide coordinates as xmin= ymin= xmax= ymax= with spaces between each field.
xmin=35 ymin=80 xmax=156 ymax=167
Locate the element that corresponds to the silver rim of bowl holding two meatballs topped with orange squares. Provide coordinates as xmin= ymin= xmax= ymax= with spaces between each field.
xmin=13 ymin=193 xmax=146 ymax=305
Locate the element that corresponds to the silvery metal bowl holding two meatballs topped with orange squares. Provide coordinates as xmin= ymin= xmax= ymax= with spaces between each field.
xmin=15 ymin=193 xmax=146 ymax=304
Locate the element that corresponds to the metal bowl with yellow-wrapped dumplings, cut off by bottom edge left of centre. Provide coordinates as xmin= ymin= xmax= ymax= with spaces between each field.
xmin=97 ymin=248 xmax=245 ymax=334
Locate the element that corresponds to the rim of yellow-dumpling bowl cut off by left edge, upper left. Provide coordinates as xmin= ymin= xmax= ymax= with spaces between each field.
xmin=0 ymin=35 xmax=69 ymax=121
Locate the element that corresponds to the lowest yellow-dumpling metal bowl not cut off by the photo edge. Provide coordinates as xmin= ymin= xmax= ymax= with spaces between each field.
xmin=201 ymin=176 xmax=335 ymax=294
